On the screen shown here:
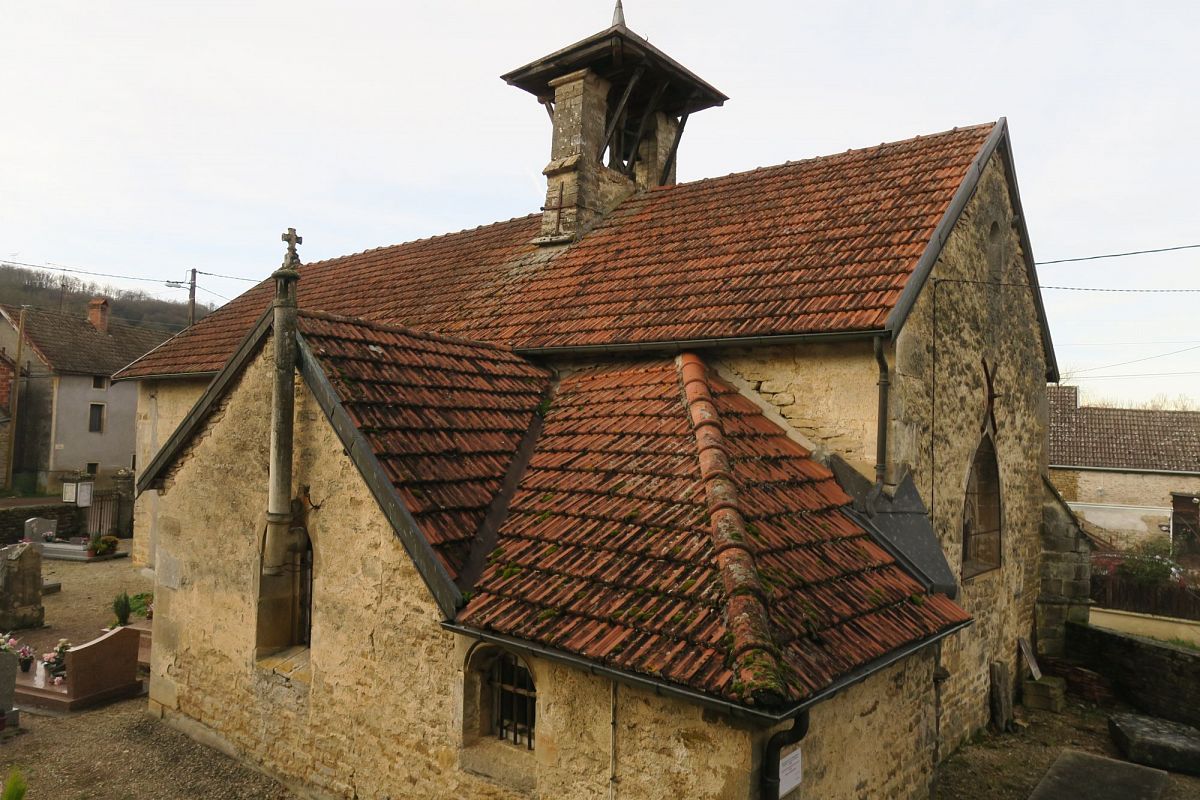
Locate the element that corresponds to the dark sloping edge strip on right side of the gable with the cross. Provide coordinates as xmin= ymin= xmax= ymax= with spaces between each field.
xmin=296 ymin=331 xmax=463 ymax=619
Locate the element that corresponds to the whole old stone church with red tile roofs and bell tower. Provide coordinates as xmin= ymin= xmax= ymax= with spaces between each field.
xmin=120 ymin=10 xmax=1074 ymax=800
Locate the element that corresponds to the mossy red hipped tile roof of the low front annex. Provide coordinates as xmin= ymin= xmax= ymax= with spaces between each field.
xmin=458 ymin=356 xmax=968 ymax=706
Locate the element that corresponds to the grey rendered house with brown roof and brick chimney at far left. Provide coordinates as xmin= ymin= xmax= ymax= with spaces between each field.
xmin=0 ymin=297 xmax=167 ymax=492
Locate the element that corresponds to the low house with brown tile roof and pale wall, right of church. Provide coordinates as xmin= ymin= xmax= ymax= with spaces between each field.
xmin=1046 ymin=386 xmax=1200 ymax=546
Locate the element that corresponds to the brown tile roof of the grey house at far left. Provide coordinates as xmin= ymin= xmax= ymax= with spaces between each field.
xmin=0 ymin=306 xmax=172 ymax=375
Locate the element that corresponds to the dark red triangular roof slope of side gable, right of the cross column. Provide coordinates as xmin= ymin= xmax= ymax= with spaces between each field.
xmin=299 ymin=312 xmax=550 ymax=578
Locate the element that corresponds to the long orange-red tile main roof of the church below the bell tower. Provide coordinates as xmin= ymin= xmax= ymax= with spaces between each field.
xmin=114 ymin=125 xmax=995 ymax=377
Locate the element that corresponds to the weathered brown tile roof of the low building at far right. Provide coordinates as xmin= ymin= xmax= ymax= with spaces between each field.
xmin=1046 ymin=386 xmax=1200 ymax=473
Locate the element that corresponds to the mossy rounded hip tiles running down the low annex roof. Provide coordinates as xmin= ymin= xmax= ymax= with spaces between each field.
xmin=678 ymin=353 xmax=788 ymax=705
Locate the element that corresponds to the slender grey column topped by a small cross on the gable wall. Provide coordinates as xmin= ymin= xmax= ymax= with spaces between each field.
xmin=263 ymin=228 xmax=304 ymax=575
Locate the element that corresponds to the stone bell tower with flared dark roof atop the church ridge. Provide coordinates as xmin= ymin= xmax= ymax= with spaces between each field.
xmin=503 ymin=13 xmax=726 ymax=245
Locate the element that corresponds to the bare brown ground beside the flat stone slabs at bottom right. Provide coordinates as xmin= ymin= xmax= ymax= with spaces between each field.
xmin=934 ymin=703 xmax=1200 ymax=800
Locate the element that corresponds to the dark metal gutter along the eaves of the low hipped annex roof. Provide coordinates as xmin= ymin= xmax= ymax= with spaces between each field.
xmin=442 ymin=620 xmax=974 ymax=726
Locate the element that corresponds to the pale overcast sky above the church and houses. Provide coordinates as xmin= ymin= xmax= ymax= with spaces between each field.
xmin=0 ymin=0 xmax=1200 ymax=402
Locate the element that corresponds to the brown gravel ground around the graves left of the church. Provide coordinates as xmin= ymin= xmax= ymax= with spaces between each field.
xmin=0 ymin=541 xmax=294 ymax=800
